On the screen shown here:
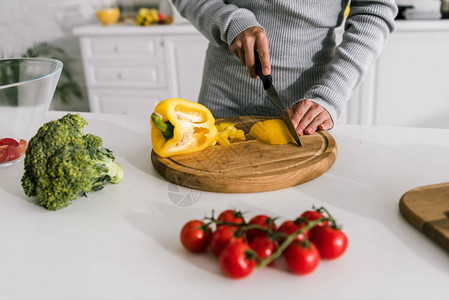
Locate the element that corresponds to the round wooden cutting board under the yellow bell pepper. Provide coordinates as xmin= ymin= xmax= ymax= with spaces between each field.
xmin=151 ymin=116 xmax=337 ymax=193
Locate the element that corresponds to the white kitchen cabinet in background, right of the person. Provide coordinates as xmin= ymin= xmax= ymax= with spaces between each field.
xmin=342 ymin=20 xmax=449 ymax=128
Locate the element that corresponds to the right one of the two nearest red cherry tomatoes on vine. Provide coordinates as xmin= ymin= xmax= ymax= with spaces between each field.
xmin=284 ymin=241 xmax=320 ymax=275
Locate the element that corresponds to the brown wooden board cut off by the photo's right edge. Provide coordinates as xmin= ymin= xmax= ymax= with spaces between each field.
xmin=399 ymin=182 xmax=449 ymax=251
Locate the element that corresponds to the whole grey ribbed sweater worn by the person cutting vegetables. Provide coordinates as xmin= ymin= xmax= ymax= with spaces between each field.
xmin=172 ymin=0 xmax=397 ymax=122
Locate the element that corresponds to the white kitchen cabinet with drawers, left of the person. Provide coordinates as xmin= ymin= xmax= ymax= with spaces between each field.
xmin=74 ymin=24 xmax=208 ymax=115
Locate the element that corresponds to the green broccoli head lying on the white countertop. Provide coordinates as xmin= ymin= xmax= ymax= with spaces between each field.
xmin=22 ymin=114 xmax=123 ymax=210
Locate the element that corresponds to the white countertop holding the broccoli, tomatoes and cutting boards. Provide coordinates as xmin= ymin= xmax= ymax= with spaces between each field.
xmin=0 ymin=112 xmax=449 ymax=300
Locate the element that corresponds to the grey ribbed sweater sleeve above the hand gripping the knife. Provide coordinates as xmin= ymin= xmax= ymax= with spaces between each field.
xmin=172 ymin=0 xmax=262 ymax=47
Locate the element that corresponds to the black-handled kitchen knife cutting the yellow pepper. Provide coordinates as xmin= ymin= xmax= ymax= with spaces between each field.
xmin=254 ymin=49 xmax=302 ymax=147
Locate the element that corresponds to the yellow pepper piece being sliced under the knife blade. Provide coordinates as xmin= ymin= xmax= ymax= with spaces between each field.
xmin=249 ymin=119 xmax=295 ymax=145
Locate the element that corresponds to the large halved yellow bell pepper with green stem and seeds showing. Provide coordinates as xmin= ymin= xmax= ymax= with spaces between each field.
xmin=151 ymin=98 xmax=217 ymax=157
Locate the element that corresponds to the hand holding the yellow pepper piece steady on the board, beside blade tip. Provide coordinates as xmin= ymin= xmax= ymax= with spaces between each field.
xmin=287 ymin=99 xmax=334 ymax=135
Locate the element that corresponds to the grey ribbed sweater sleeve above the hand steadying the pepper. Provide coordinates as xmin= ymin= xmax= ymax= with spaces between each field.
xmin=304 ymin=0 xmax=397 ymax=123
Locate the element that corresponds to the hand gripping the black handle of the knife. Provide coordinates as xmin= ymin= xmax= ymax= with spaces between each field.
xmin=230 ymin=26 xmax=271 ymax=78
